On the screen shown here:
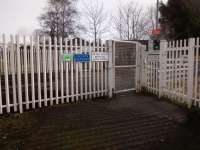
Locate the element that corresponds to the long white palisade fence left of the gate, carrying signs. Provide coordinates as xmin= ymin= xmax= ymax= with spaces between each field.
xmin=0 ymin=35 xmax=112 ymax=114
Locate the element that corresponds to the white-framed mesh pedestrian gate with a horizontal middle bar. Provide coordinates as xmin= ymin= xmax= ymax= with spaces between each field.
xmin=113 ymin=41 xmax=140 ymax=93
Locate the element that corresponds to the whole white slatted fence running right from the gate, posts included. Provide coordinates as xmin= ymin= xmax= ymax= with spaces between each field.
xmin=143 ymin=38 xmax=200 ymax=106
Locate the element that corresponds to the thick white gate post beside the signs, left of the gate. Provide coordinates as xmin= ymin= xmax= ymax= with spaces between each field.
xmin=107 ymin=40 xmax=114 ymax=98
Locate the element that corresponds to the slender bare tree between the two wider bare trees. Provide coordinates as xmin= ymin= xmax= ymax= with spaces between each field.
xmin=83 ymin=0 xmax=108 ymax=42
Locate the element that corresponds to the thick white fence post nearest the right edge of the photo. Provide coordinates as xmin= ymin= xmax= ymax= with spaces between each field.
xmin=187 ymin=38 xmax=195 ymax=107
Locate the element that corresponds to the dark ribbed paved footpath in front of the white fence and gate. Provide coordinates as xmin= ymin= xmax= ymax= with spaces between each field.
xmin=0 ymin=93 xmax=186 ymax=150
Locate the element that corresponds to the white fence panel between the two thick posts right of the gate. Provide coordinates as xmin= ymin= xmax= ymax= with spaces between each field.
xmin=159 ymin=40 xmax=190 ymax=102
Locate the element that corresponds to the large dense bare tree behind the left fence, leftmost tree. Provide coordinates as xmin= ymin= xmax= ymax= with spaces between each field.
xmin=39 ymin=0 xmax=79 ymax=38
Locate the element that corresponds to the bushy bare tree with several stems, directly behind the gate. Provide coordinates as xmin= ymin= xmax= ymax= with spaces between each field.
xmin=114 ymin=2 xmax=149 ymax=40
